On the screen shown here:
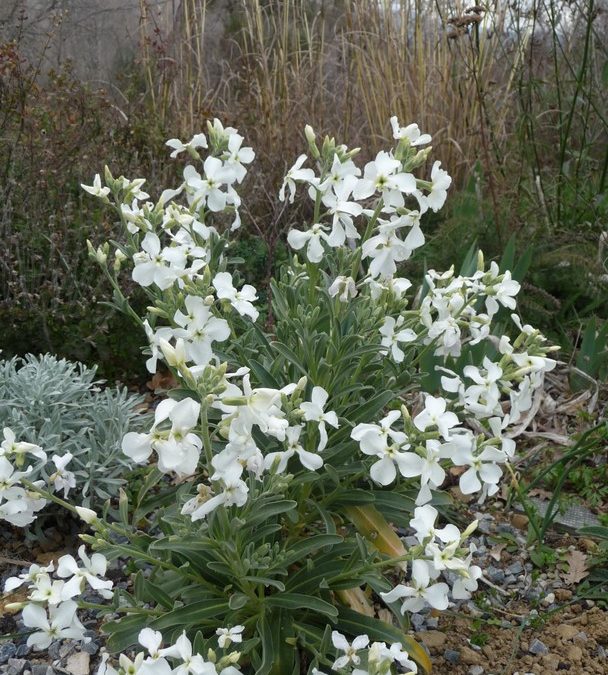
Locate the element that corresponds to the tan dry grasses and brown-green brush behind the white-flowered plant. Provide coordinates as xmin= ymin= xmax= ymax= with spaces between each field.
xmin=0 ymin=0 xmax=608 ymax=378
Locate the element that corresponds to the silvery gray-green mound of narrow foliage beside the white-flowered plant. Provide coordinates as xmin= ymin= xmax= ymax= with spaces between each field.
xmin=0 ymin=354 xmax=149 ymax=505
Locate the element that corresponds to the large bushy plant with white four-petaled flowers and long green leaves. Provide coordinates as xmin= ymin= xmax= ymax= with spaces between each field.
xmin=3 ymin=118 xmax=554 ymax=675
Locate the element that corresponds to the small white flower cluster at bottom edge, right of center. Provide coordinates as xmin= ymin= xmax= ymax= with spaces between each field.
xmin=312 ymin=630 xmax=418 ymax=675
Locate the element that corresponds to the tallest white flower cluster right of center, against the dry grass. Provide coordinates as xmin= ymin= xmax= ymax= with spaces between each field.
xmin=279 ymin=117 xmax=452 ymax=272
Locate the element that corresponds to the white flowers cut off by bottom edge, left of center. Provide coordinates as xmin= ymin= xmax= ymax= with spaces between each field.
xmin=97 ymin=626 xmax=244 ymax=675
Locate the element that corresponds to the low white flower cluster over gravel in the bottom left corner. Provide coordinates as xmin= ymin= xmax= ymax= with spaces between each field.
xmin=4 ymin=546 xmax=112 ymax=650
